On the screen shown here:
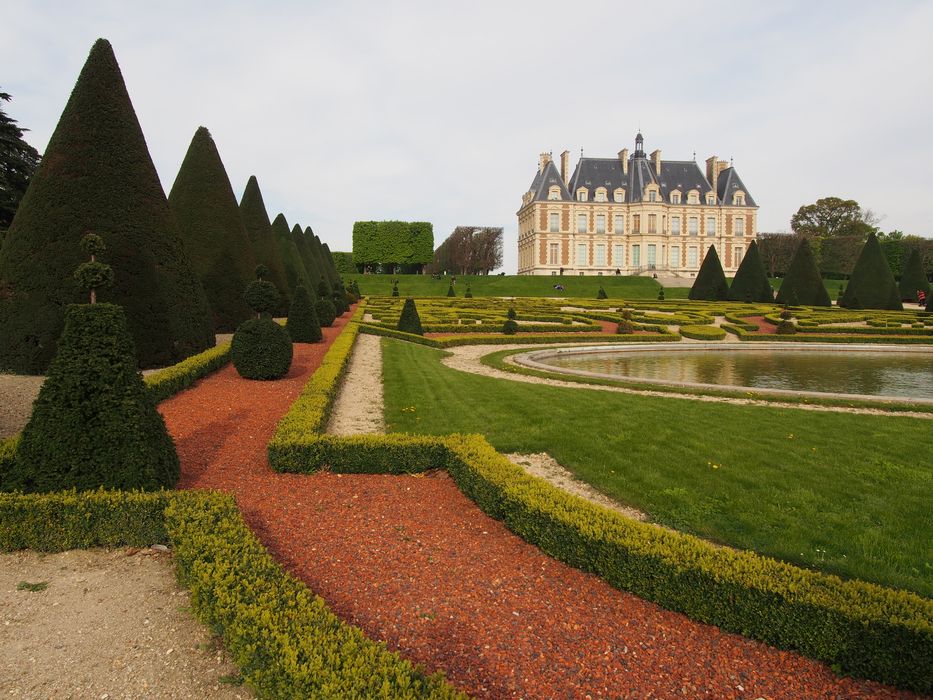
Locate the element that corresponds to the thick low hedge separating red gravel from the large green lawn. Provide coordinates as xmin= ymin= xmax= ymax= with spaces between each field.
xmin=268 ymin=435 xmax=933 ymax=692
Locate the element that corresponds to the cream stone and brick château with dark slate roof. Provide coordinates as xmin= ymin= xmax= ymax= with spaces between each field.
xmin=518 ymin=134 xmax=758 ymax=277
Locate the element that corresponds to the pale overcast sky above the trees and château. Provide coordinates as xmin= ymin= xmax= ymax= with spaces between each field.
xmin=0 ymin=0 xmax=933 ymax=274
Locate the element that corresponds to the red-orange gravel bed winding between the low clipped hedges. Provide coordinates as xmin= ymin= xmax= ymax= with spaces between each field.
xmin=160 ymin=319 xmax=912 ymax=699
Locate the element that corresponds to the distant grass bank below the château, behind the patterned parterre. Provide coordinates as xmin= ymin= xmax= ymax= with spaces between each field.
xmin=343 ymin=275 xmax=659 ymax=299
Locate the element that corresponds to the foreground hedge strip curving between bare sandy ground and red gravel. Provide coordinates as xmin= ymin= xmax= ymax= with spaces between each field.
xmin=165 ymin=493 xmax=465 ymax=698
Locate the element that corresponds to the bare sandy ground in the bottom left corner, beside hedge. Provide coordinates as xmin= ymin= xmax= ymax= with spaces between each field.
xmin=0 ymin=549 xmax=254 ymax=699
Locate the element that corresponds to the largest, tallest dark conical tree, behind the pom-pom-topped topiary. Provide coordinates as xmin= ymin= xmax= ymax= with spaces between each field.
xmin=0 ymin=39 xmax=214 ymax=373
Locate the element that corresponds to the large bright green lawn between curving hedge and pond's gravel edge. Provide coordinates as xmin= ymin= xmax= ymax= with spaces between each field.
xmin=383 ymin=340 xmax=933 ymax=596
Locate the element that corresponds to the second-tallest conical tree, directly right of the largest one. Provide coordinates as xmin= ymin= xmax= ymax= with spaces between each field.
xmin=168 ymin=126 xmax=256 ymax=333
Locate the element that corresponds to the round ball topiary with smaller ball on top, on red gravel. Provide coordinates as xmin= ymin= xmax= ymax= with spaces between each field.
xmin=230 ymin=265 xmax=293 ymax=380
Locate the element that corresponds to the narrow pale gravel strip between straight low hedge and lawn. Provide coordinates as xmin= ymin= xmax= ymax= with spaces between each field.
xmin=327 ymin=333 xmax=385 ymax=435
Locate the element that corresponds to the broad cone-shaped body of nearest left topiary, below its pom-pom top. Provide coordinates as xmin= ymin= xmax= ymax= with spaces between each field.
xmin=3 ymin=304 xmax=179 ymax=492
